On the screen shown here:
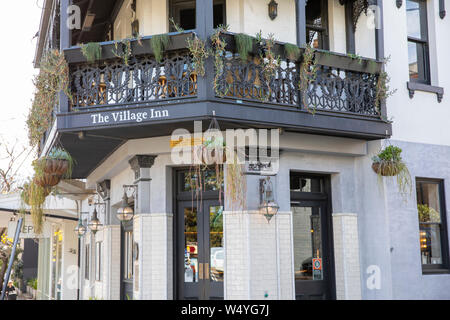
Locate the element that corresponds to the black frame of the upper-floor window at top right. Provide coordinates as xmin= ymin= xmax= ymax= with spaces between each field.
xmin=407 ymin=0 xmax=431 ymax=85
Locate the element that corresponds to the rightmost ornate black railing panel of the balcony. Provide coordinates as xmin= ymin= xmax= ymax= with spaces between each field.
xmin=306 ymin=66 xmax=378 ymax=116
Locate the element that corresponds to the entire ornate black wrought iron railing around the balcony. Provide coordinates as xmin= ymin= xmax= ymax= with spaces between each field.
xmin=66 ymin=32 xmax=381 ymax=117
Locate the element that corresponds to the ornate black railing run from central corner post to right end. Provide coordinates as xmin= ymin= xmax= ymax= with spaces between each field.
xmin=217 ymin=53 xmax=378 ymax=116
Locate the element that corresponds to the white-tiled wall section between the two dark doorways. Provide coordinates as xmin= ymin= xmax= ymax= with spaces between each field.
xmin=224 ymin=211 xmax=294 ymax=300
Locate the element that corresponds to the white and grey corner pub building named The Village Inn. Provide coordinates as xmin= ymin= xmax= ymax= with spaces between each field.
xmin=36 ymin=0 xmax=450 ymax=300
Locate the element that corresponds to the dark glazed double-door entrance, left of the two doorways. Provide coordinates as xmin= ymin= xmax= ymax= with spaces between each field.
xmin=174 ymin=170 xmax=225 ymax=300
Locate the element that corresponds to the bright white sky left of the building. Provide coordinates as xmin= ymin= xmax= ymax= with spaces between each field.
xmin=0 ymin=0 xmax=44 ymax=176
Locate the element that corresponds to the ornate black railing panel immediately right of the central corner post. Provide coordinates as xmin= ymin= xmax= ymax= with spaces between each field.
xmin=217 ymin=53 xmax=299 ymax=106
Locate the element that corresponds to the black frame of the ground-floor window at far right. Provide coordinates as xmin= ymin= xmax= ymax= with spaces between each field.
xmin=416 ymin=177 xmax=450 ymax=275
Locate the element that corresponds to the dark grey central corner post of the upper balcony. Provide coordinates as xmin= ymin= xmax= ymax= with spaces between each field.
xmin=195 ymin=0 xmax=214 ymax=100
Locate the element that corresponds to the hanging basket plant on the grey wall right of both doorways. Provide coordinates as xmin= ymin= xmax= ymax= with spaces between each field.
xmin=372 ymin=146 xmax=412 ymax=194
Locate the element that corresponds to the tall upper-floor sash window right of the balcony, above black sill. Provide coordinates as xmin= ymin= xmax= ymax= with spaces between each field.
xmin=406 ymin=0 xmax=430 ymax=84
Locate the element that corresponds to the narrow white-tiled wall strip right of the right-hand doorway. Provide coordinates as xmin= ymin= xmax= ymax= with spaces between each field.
xmin=333 ymin=213 xmax=361 ymax=300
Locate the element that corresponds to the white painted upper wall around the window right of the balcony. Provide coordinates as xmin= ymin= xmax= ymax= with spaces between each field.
xmin=384 ymin=0 xmax=450 ymax=146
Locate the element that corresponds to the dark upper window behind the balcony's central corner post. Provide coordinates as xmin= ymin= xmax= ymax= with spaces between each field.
xmin=169 ymin=0 xmax=226 ymax=32
